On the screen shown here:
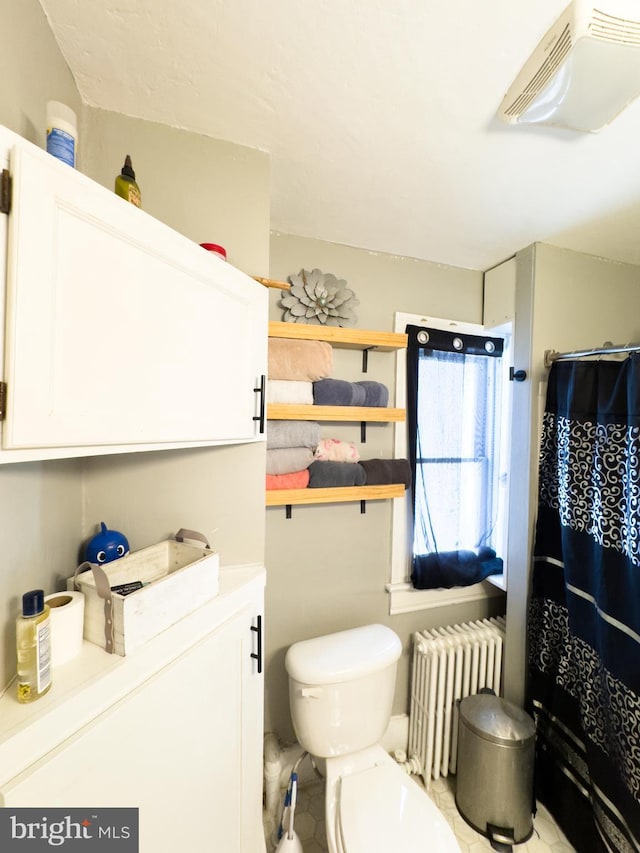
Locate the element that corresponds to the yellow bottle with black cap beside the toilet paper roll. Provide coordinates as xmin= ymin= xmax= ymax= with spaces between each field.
xmin=16 ymin=589 xmax=51 ymax=702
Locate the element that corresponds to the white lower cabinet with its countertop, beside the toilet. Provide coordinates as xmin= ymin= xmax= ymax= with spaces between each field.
xmin=0 ymin=566 xmax=265 ymax=853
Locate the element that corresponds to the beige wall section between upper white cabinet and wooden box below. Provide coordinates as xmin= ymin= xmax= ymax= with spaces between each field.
xmin=83 ymin=443 xmax=265 ymax=566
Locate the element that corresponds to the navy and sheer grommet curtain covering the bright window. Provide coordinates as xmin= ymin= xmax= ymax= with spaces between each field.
xmin=406 ymin=326 xmax=503 ymax=589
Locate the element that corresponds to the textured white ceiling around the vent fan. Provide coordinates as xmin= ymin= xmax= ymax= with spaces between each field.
xmin=40 ymin=0 xmax=640 ymax=270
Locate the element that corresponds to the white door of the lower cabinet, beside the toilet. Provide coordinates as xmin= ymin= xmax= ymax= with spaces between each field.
xmin=0 ymin=611 xmax=264 ymax=853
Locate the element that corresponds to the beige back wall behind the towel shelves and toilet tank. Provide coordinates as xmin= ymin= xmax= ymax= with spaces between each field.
xmin=266 ymin=234 xmax=504 ymax=741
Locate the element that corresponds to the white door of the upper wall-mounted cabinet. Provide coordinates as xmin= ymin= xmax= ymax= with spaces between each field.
xmin=2 ymin=135 xmax=267 ymax=452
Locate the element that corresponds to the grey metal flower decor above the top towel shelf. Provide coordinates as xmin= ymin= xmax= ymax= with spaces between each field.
xmin=280 ymin=269 xmax=360 ymax=326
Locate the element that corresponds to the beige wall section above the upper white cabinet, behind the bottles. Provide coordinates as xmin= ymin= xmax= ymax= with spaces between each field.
xmin=82 ymin=107 xmax=271 ymax=276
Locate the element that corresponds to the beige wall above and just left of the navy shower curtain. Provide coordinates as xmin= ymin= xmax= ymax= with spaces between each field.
xmin=505 ymin=243 xmax=640 ymax=703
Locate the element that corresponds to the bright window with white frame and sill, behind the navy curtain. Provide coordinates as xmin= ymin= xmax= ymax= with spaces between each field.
xmin=387 ymin=312 xmax=512 ymax=615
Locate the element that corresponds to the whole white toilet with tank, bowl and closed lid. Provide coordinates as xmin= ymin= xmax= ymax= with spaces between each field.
xmin=285 ymin=625 xmax=460 ymax=853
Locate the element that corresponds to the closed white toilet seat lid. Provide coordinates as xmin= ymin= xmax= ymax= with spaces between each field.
xmin=339 ymin=763 xmax=460 ymax=853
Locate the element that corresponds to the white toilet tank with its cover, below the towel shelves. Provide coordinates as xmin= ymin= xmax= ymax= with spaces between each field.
xmin=285 ymin=625 xmax=402 ymax=758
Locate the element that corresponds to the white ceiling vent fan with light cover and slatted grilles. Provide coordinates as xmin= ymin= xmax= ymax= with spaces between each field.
xmin=498 ymin=0 xmax=640 ymax=132
